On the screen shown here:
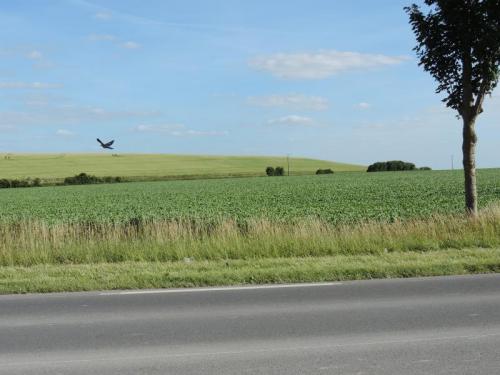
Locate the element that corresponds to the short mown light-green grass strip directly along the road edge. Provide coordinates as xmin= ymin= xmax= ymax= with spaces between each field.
xmin=0 ymin=249 xmax=500 ymax=294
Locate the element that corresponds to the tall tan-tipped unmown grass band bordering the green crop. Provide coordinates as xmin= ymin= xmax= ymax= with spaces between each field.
xmin=0 ymin=205 xmax=500 ymax=266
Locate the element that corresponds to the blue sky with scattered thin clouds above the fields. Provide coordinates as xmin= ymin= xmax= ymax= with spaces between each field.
xmin=0 ymin=0 xmax=500 ymax=169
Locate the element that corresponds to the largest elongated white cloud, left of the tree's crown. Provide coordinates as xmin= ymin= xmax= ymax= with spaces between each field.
xmin=250 ymin=50 xmax=408 ymax=79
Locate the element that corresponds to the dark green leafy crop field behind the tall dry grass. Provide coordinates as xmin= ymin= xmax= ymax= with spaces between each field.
xmin=0 ymin=169 xmax=500 ymax=224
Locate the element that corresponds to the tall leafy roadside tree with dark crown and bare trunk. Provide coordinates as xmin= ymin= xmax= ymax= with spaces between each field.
xmin=405 ymin=0 xmax=500 ymax=216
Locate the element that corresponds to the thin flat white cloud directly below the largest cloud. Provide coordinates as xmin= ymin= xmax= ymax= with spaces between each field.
xmin=247 ymin=94 xmax=328 ymax=111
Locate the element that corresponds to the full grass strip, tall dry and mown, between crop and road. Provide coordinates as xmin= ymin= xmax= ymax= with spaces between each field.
xmin=0 ymin=205 xmax=500 ymax=293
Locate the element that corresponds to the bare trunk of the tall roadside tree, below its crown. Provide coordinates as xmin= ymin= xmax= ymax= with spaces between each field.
xmin=462 ymin=116 xmax=477 ymax=217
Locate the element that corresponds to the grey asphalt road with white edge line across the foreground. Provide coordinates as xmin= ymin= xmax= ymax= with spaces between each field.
xmin=0 ymin=275 xmax=500 ymax=375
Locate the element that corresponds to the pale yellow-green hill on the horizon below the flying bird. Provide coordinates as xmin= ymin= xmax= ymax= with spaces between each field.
xmin=0 ymin=153 xmax=365 ymax=180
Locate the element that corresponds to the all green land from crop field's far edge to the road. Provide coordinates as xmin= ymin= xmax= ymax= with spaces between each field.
xmin=0 ymin=169 xmax=500 ymax=293
